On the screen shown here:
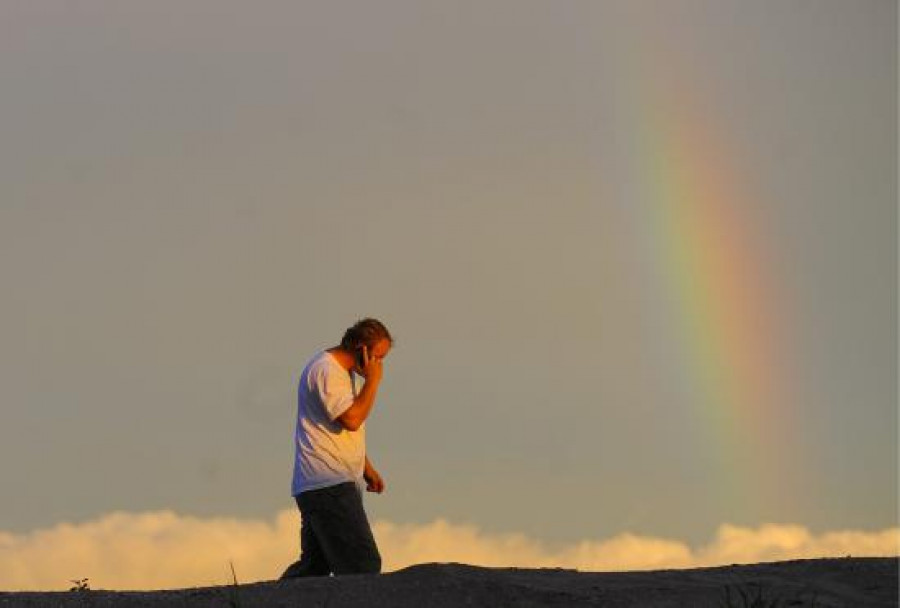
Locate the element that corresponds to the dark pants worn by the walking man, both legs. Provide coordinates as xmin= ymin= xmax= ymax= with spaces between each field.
xmin=281 ymin=481 xmax=381 ymax=578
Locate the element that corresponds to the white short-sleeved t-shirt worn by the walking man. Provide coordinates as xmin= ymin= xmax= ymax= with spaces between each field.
xmin=291 ymin=350 xmax=366 ymax=496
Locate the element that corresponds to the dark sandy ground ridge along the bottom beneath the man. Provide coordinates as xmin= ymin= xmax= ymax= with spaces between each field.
xmin=0 ymin=557 xmax=900 ymax=608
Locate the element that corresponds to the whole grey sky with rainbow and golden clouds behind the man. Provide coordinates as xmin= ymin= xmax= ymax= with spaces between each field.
xmin=0 ymin=0 xmax=900 ymax=588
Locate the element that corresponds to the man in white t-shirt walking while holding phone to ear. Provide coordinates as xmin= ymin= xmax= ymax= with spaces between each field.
xmin=281 ymin=319 xmax=394 ymax=578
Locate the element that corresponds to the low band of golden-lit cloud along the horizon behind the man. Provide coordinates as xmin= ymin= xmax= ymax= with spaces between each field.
xmin=0 ymin=510 xmax=900 ymax=590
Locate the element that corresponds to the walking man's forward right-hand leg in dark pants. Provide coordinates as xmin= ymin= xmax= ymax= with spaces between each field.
xmin=298 ymin=481 xmax=381 ymax=575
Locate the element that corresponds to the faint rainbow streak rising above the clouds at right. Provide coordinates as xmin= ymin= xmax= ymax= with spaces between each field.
xmin=620 ymin=16 xmax=800 ymax=513
